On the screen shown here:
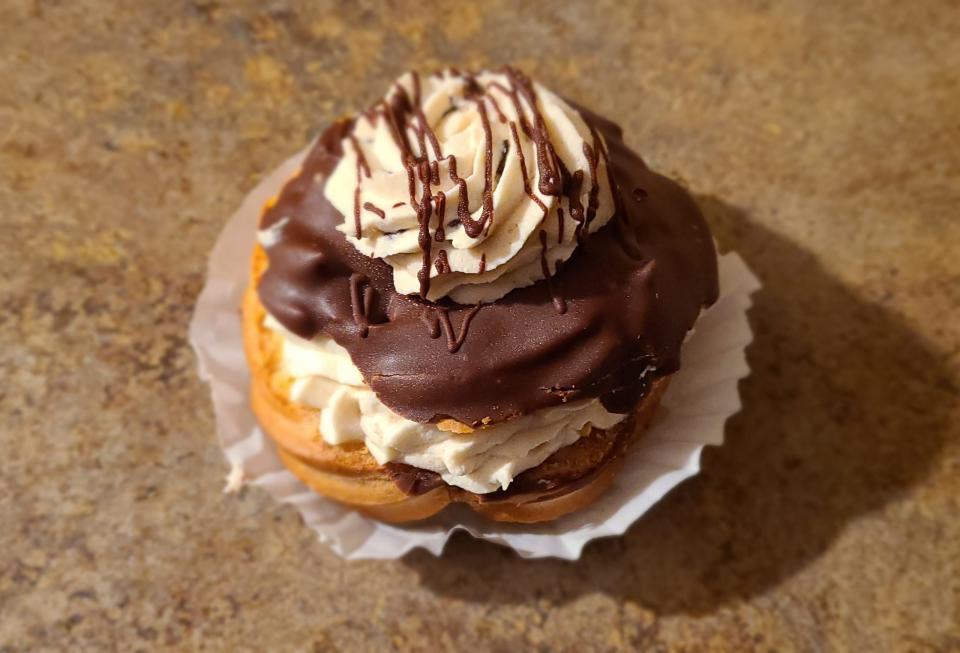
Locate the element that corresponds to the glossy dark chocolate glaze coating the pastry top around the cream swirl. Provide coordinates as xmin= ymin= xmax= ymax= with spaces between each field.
xmin=259 ymin=97 xmax=718 ymax=425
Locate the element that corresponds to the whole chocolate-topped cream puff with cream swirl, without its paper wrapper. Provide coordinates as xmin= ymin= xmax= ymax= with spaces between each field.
xmin=243 ymin=68 xmax=718 ymax=522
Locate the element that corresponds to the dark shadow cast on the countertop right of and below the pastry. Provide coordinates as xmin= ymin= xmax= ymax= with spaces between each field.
xmin=404 ymin=197 xmax=955 ymax=614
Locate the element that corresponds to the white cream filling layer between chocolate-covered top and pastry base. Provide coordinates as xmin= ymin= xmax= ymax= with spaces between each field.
xmin=264 ymin=316 xmax=625 ymax=494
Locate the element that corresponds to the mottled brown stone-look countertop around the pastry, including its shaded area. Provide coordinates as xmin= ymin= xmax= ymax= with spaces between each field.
xmin=0 ymin=0 xmax=960 ymax=653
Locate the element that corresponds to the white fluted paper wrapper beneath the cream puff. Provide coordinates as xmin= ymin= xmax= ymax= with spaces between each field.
xmin=190 ymin=150 xmax=760 ymax=560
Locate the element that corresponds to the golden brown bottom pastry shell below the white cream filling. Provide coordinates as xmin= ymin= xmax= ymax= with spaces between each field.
xmin=243 ymin=246 xmax=668 ymax=523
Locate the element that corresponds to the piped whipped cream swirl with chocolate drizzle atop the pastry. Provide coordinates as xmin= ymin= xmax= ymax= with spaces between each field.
xmin=325 ymin=69 xmax=614 ymax=304
